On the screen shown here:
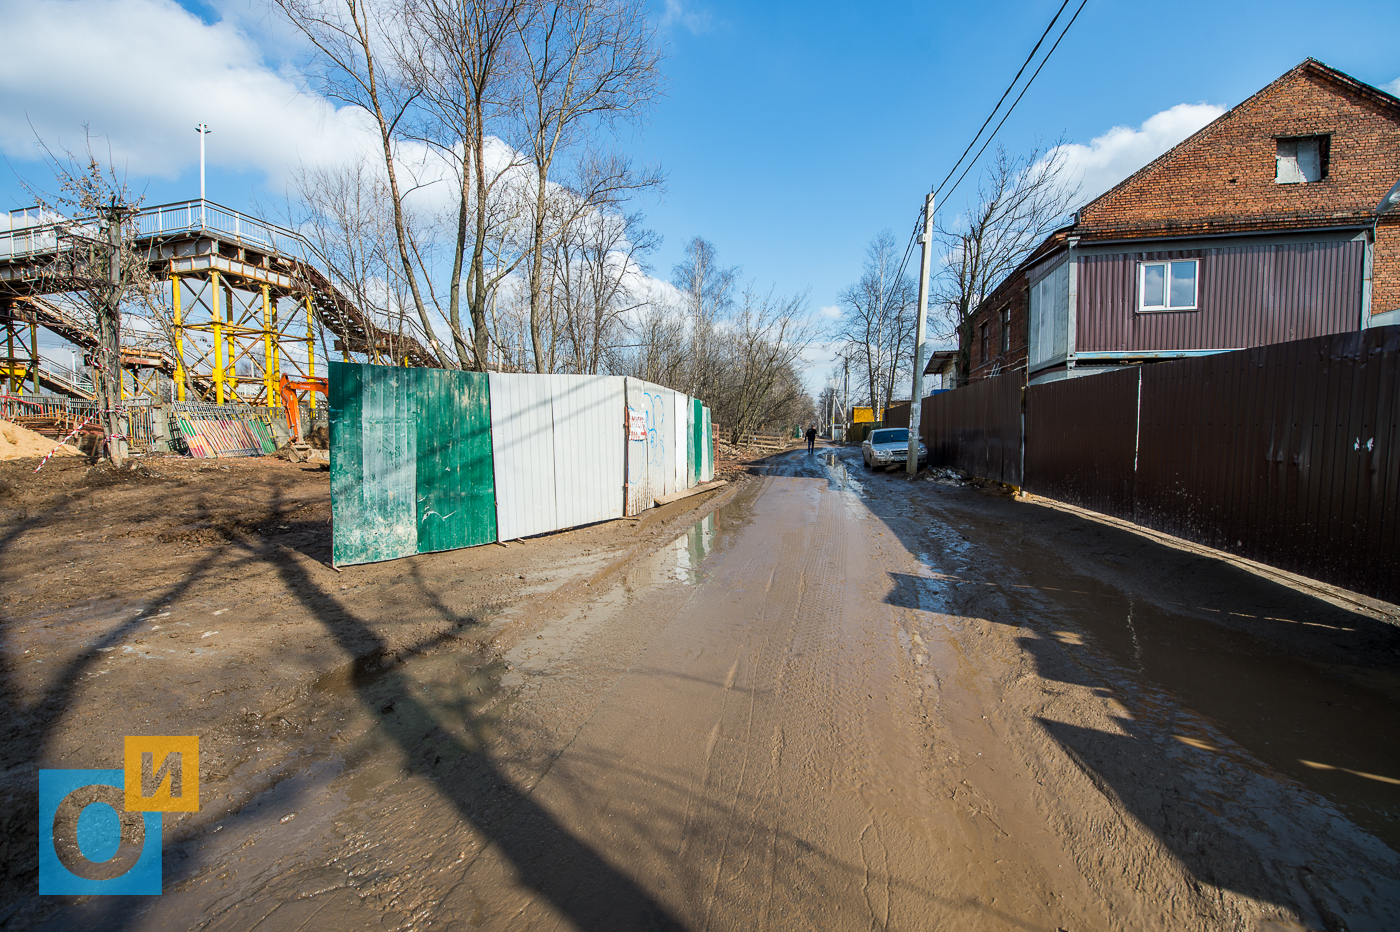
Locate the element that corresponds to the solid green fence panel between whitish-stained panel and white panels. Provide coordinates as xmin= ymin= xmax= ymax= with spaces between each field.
xmin=399 ymin=369 xmax=496 ymax=553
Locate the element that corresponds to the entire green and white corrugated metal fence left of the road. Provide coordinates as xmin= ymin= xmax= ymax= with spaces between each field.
xmin=329 ymin=362 xmax=714 ymax=565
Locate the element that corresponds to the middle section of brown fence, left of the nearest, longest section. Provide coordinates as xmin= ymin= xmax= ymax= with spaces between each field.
xmin=1023 ymin=368 xmax=1140 ymax=521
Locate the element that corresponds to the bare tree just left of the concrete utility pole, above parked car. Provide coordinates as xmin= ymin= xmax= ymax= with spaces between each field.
xmin=839 ymin=230 xmax=918 ymax=409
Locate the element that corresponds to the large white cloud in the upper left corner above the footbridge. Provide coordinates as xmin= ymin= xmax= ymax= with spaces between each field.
xmin=0 ymin=0 xmax=374 ymax=186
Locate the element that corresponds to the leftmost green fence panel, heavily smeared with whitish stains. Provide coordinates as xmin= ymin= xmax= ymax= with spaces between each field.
xmin=329 ymin=361 xmax=419 ymax=564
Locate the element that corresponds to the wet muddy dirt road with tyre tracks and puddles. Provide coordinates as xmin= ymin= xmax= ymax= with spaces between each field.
xmin=17 ymin=448 xmax=1400 ymax=931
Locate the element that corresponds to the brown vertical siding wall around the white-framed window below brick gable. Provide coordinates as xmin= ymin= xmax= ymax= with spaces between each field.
xmin=1075 ymin=241 xmax=1365 ymax=353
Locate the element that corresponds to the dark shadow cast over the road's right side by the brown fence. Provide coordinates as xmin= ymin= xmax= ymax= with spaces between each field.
xmin=774 ymin=448 xmax=1400 ymax=928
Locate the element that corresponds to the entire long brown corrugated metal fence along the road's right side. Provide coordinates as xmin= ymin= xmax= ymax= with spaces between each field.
xmin=923 ymin=326 xmax=1400 ymax=602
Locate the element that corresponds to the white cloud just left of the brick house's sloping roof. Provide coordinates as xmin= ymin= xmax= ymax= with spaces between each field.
xmin=1046 ymin=104 xmax=1225 ymax=202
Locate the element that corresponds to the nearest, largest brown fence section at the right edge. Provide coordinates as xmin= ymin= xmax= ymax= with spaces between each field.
xmin=1134 ymin=327 xmax=1400 ymax=602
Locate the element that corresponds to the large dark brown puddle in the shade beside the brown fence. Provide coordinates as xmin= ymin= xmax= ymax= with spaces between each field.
xmin=1030 ymin=574 xmax=1400 ymax=851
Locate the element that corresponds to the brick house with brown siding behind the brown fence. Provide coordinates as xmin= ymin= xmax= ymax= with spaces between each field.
xmin=966 ymin=59 xmax=1400 ymax=382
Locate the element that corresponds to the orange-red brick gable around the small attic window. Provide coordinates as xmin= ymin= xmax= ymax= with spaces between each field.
xmin=1075 ymin=62 xmax=1400 ymax=242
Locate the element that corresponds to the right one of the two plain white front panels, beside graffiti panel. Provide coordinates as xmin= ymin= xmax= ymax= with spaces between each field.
xmin=548 ymin=375 xmax=627 ymax=528
